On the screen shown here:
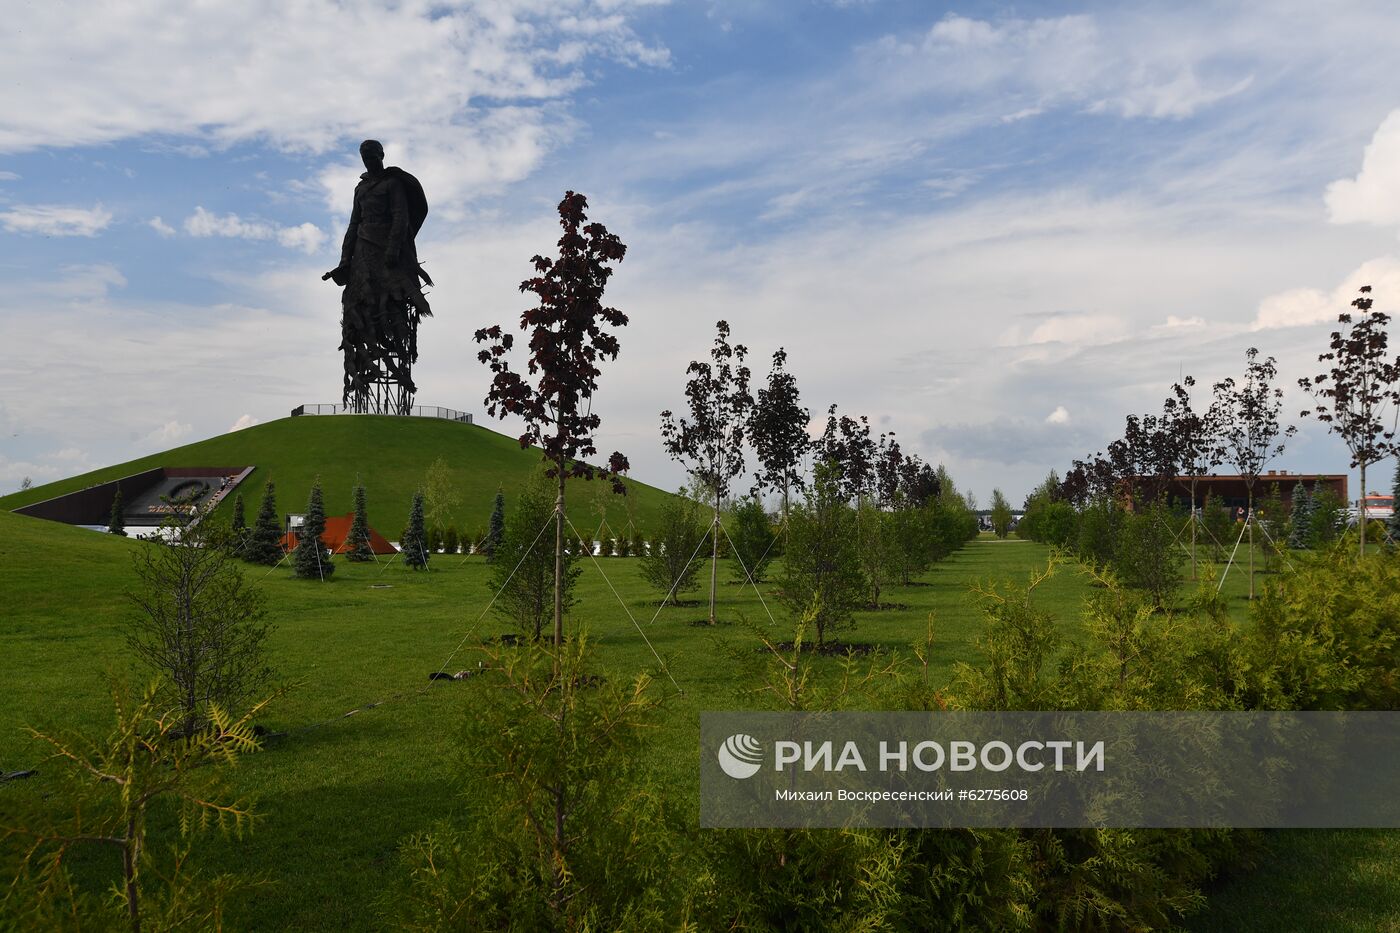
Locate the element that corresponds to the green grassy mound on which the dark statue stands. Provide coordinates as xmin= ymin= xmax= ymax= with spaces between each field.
xmin=0 ymin=415 xmax=668 ymax=539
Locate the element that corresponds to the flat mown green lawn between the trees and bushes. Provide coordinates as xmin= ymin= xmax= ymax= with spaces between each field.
xmin=0 ymin=513 xmax=1400 ymax=932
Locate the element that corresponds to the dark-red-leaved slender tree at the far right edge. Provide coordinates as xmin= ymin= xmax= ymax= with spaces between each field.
xmin=1298 ymin=286 xmax=1400 ymax=556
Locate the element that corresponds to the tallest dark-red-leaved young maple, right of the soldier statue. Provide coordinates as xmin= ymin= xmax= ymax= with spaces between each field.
xmin=475 ymin=191 xmax=627 ymax=652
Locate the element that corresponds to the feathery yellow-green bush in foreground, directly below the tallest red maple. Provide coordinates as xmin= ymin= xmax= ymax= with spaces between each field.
xmin=382 ymin=632 xmax=690 ymax=930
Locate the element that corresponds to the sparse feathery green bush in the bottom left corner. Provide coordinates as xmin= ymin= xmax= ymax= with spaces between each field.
xmin=0 ymin=681 xmax=265 ymax=932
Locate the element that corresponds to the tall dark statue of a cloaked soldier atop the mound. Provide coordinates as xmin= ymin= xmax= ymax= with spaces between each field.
xmin=321 ymin=139 xmax=433 ymax=415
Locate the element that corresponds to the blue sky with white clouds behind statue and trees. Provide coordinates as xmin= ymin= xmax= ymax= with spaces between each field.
xmin=0 ymin=0 xmax=1400 ymax=502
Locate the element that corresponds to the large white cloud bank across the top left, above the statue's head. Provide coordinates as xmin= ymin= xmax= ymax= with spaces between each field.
xmin=0 ymin=0 xmax=669 ymax=206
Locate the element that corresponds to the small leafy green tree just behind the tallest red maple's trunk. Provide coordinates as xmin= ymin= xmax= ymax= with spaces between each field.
xmin=487 ymin=471 xmax=582 ymax=639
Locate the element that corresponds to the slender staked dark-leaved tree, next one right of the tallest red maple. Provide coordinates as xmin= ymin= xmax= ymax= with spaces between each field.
xmin=661 ymin=321 xmax=753 ymax=625
